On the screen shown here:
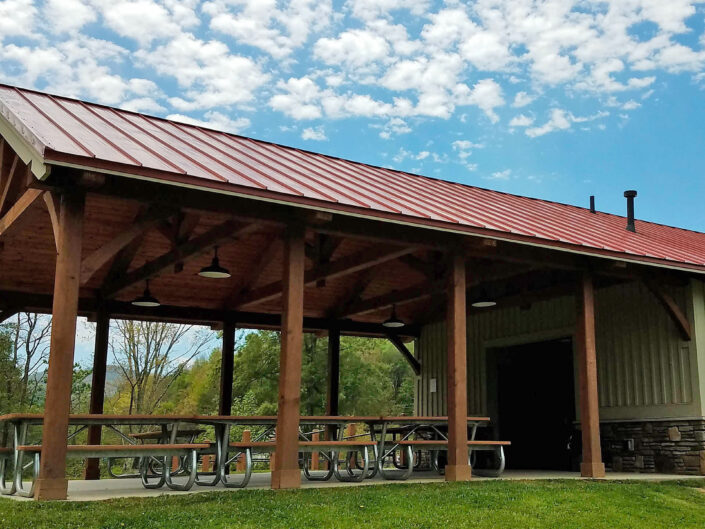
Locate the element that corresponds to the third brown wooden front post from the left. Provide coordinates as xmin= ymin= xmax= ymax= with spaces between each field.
xmin=445 ymin=253 xmax=471 ymax=481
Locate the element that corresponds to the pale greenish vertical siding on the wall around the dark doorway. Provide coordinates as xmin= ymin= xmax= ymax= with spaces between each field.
xmin=416 ymin=283 xmax=705 ymax=419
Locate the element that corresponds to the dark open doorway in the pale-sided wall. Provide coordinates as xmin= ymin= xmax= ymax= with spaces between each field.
xmin=488 ymin=338 xmax=580 ymax=470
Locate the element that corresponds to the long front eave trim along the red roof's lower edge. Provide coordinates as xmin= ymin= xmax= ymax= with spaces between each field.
xmin=42 ymin=155 xmax=705 ymax=275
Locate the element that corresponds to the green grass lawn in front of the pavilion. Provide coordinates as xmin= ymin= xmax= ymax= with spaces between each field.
xmin=0 ymin=480 xmax=705 ymax=529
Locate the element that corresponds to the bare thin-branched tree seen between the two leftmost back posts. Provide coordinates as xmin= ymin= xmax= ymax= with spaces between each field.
xmin=110 ymin=320 xmax=212 ymax=414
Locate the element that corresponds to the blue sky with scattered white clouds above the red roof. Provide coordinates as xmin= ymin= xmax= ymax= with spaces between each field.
xmin=0 ymin=0 xmax=705 ymax=231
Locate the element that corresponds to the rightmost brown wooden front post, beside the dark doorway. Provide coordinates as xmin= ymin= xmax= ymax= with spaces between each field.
xmin=575 ymin=273 xmax=605 ymax=478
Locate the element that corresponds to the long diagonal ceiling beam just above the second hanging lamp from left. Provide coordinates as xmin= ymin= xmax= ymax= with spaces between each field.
xmin=101 ymin=220 xmax=259 ymax=299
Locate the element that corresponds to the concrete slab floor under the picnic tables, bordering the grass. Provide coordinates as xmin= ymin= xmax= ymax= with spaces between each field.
xmin=4 ymin=470 xmax=703 ymax=501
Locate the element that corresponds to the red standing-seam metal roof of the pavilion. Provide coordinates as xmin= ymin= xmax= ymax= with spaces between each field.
xmin=0 ymin=85 xmax=705 ymax=270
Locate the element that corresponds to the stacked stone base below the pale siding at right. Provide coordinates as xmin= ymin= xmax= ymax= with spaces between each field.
xmin=600 ymin=420 xmax=705 ymax=475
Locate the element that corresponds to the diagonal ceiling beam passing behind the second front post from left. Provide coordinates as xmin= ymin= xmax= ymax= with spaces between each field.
xmin=239 ymin=246 xmax=416 ymax=307
